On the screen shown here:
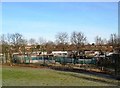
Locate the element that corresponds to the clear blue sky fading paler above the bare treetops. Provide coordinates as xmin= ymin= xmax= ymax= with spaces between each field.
xmin=2 ymin=2 xmax=118 ymax=43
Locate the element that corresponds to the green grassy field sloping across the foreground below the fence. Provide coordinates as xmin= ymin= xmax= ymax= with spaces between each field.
xmin=2 ymin=66 xmax=118 ymax=86
